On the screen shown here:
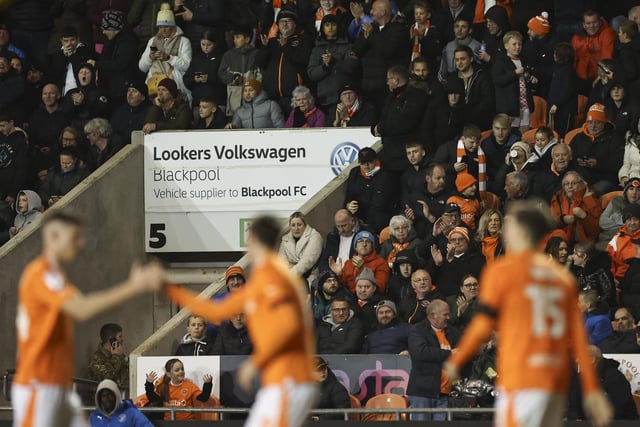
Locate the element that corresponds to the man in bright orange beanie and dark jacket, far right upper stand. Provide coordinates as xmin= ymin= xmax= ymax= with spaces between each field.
xmin=571 ymin=104 xmax=624 ymax=194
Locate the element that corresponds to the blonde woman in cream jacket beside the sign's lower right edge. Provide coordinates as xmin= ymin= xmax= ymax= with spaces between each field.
xmin=280 ymin=212 xmax=322 ymax=283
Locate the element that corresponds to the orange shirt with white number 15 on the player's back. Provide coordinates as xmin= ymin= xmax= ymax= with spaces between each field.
xmin=480 ymin=252 xmax=584 ymax=392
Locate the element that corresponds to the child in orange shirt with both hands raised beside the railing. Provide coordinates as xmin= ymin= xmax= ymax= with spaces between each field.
xmin=144 ymin=358 xmax=213 ymax=421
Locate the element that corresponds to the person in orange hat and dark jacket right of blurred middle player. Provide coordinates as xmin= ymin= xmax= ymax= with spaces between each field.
xmin=311 ymin=358 xmax=351 ymax=421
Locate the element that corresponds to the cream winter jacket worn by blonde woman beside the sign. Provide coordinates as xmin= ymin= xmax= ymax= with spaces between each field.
xmin=280 ymin=224 xmax=322 ymax=281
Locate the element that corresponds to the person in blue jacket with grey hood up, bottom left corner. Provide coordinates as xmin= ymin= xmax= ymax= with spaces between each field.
xmin=89 ymin=380 xmax=153 ymax=427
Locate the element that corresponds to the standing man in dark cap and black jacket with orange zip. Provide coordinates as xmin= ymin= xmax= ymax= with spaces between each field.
xmin=256 ymin=9 xmax=311 ymax=114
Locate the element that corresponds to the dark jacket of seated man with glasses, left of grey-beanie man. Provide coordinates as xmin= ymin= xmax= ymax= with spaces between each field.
xmin=316 ymin=310 xmax=364 ymax=354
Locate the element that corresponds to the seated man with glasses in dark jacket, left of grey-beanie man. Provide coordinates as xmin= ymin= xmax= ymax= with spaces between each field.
xmin=316 ymin=298 xmax=364 ymax=354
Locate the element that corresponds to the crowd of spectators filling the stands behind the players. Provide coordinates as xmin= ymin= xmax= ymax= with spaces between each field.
xmin=6 ymin=0 xmax=640 ymax=417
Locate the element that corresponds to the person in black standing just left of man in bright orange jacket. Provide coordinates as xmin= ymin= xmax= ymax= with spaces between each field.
xmin=546 ymin=42 xmax=578 ymax=137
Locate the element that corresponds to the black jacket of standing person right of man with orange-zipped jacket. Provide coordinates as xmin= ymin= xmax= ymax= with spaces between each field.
xmin=307 ymin=37 xmax=359 ymax=105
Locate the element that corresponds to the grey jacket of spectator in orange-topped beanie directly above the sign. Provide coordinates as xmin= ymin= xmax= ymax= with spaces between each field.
xmin=231 ymin=91 xmax=284 ymax=129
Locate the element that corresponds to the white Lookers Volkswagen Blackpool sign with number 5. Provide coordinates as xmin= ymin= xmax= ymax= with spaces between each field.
xmin=144 ymin=128 xmax=375 ymax=252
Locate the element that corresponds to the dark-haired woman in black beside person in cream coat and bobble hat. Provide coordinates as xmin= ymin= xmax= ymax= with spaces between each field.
xmin=182 ymin=28 xmax=227 ymax=120
